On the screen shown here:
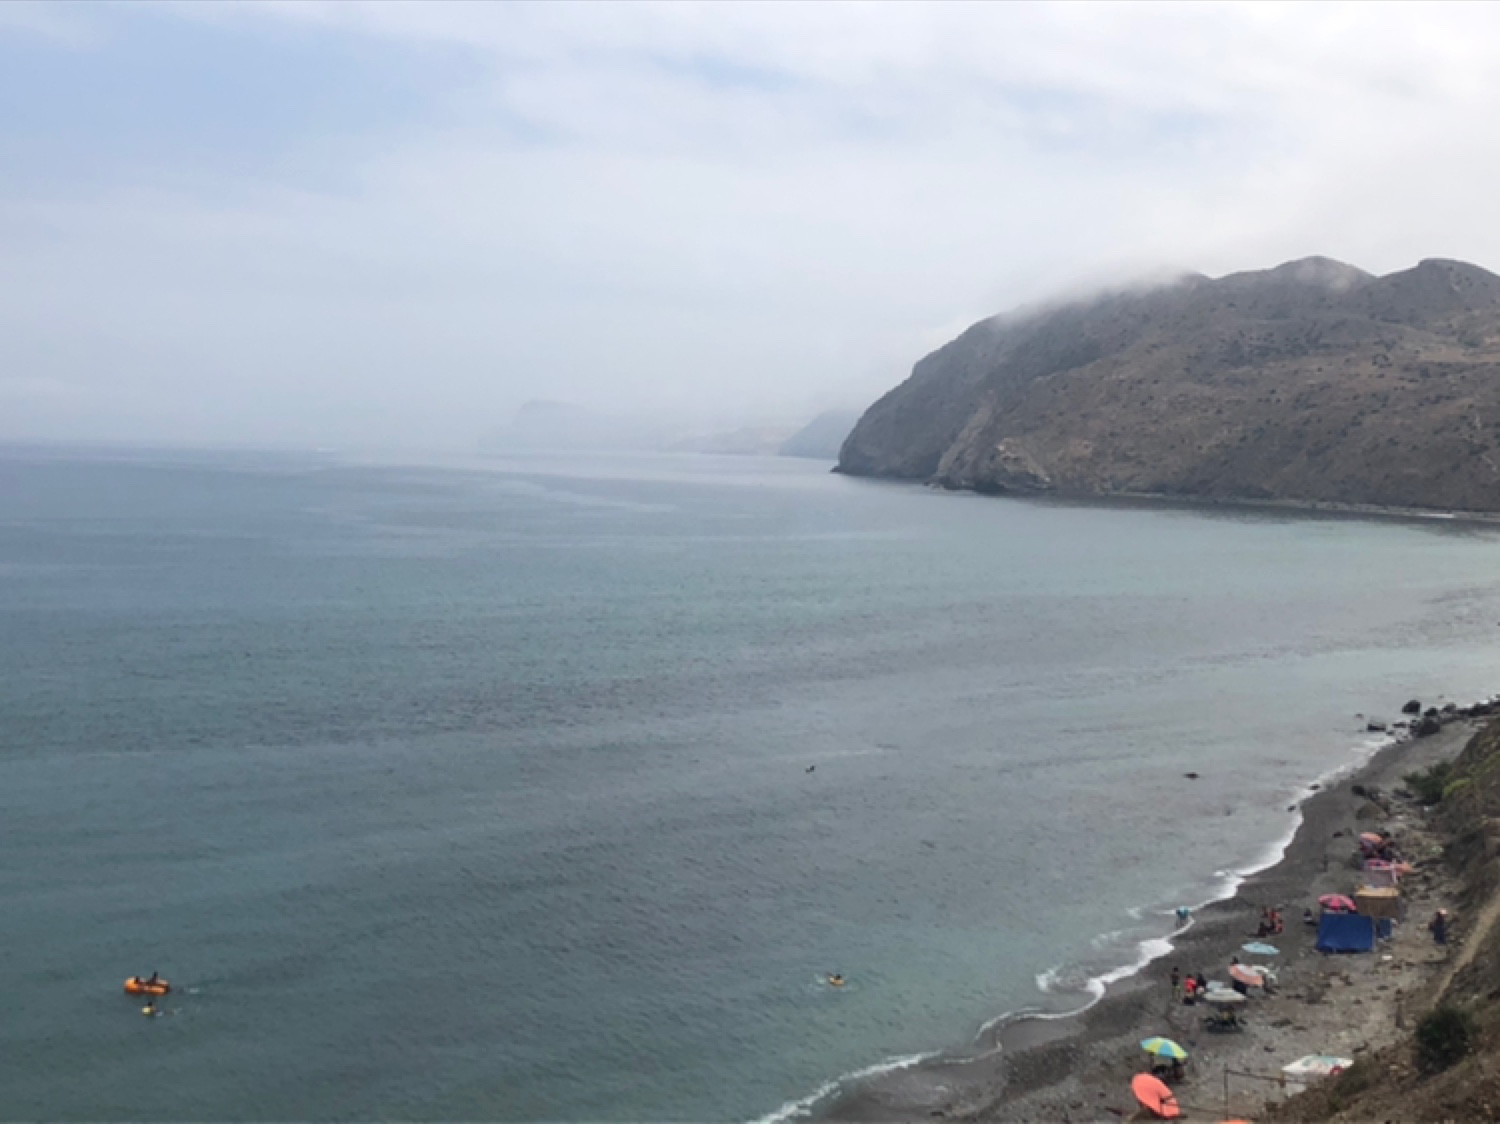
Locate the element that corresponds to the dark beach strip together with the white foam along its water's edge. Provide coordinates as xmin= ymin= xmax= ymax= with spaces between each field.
xmin=816 ymin=708 xmax=1481 ymax=1124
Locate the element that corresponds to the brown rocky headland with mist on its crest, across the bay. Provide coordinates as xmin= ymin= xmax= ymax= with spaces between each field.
xmin=839 ymin=258 xmax=1500 ymax=512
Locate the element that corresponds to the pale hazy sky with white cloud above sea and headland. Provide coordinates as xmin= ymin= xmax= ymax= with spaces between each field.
xmin=0 ymin=0 xmax=1500 ymax=450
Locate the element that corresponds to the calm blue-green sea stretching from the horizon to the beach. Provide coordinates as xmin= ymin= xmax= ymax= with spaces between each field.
xmin=0 ymin=447 xmax=1500 ymax=1121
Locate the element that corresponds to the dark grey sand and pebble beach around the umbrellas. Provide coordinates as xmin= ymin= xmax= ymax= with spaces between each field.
xmin=822 ymin=719 xmax=1478 ymax=1121
